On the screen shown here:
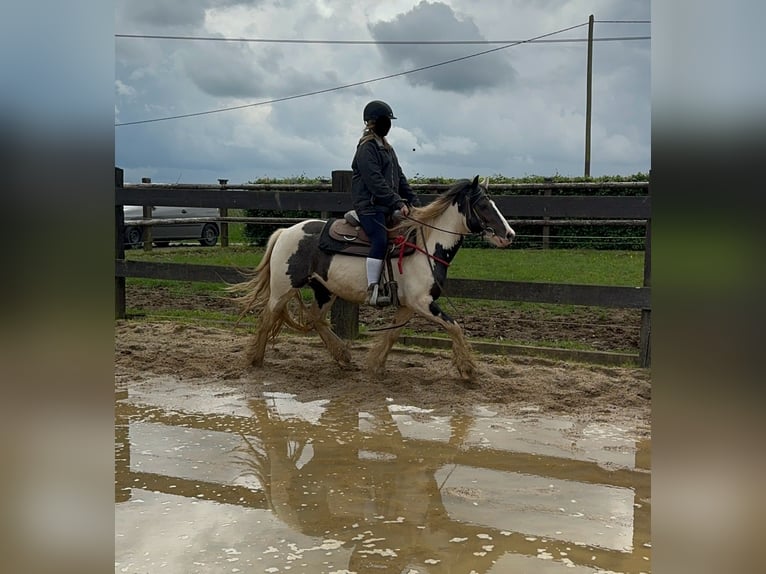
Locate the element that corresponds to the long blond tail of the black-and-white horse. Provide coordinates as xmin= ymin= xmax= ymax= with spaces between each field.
xmin=227 ymin=228 xmax=310 ymax=337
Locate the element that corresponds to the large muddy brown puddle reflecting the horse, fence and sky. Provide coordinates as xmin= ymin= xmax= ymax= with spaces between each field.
xmin=115 ymin=377 xmax=651 ymax=574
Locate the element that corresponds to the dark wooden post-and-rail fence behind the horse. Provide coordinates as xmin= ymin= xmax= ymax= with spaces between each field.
xmin=115 ymin=168 xmax=651 ymax=367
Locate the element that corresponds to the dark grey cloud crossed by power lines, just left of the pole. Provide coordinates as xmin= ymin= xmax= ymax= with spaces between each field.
xmin=370 ymin=1 xmax=516 ymax=93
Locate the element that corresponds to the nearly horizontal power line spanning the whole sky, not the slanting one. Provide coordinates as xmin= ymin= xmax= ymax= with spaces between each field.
xmin=114 ymin=34 xmax=651 ymax=46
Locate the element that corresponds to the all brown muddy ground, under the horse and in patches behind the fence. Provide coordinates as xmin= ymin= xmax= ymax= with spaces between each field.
xmin=115 ymin=288 xmax=651 ymax=436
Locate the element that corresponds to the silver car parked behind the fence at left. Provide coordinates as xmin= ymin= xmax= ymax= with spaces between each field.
xmin=123 ymin=205 xmax=221 ymax=247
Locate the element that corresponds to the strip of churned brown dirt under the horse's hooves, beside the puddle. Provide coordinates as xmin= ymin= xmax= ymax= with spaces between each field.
xmin=115 ymin=320 xmax=651 ymax=435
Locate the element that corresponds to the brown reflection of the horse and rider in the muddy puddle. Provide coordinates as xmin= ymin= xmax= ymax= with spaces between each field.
xmin=238 ymin=398 xmax=500 ymax=574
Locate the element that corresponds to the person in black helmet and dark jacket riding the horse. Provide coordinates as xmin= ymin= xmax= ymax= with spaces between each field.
xmin=351 ymin=100 xmax=420 ymax=305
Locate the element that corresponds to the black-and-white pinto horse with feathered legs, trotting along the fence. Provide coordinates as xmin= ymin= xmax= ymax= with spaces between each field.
xmin=229 ymin=176 xmax=515 ymax=380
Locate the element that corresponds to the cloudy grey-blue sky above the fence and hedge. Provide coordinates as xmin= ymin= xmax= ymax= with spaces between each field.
xmin=115 ymin=0 xmax=651 ymax=183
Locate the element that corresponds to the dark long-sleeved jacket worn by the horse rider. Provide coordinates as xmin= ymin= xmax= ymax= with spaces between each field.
xmin=351 ymin=139 xmax=420 ymax=215
